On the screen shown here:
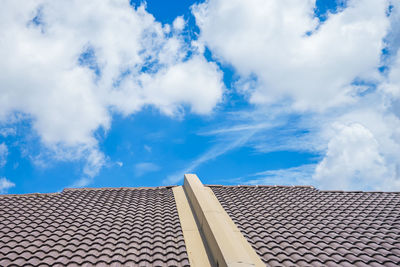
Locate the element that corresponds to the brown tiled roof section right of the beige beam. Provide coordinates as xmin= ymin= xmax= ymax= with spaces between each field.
xmin=210 ymin=186 xmax=400 ymax=266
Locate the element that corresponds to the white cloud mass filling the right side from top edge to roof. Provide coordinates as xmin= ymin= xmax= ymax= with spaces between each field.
xmin=192 ymin=0 xmax=400 ymax=190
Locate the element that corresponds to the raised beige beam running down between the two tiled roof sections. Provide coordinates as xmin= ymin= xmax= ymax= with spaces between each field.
xmin=183 ymin=174 xmax=265 ymax=267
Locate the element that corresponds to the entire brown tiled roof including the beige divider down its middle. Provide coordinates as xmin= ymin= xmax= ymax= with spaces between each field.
xmin=0 ymin=175 xmax=400 ymax=267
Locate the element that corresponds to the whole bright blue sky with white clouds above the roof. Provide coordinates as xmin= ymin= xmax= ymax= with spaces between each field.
xmin=0 ymin=0 xmax=400 ymax=194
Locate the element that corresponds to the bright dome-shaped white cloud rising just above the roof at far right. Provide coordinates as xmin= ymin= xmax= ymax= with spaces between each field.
xmin=314 ymin=123 xmax=400 ymax=190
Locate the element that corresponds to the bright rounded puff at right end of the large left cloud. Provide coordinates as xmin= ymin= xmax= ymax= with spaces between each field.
xmin=111 ymin=56 xmax=223 ymax=116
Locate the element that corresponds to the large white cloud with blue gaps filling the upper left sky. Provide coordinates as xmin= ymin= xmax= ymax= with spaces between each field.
xmin=0 ymin=0 xmax=223 ymax=185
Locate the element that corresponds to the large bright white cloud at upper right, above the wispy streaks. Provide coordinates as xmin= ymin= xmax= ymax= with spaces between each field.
xmin=193 ymin=0 xmax=389 ymax=110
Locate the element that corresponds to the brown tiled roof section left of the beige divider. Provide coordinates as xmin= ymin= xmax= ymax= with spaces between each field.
xmin=0 ymin=188 xmax=189 ymax=266
